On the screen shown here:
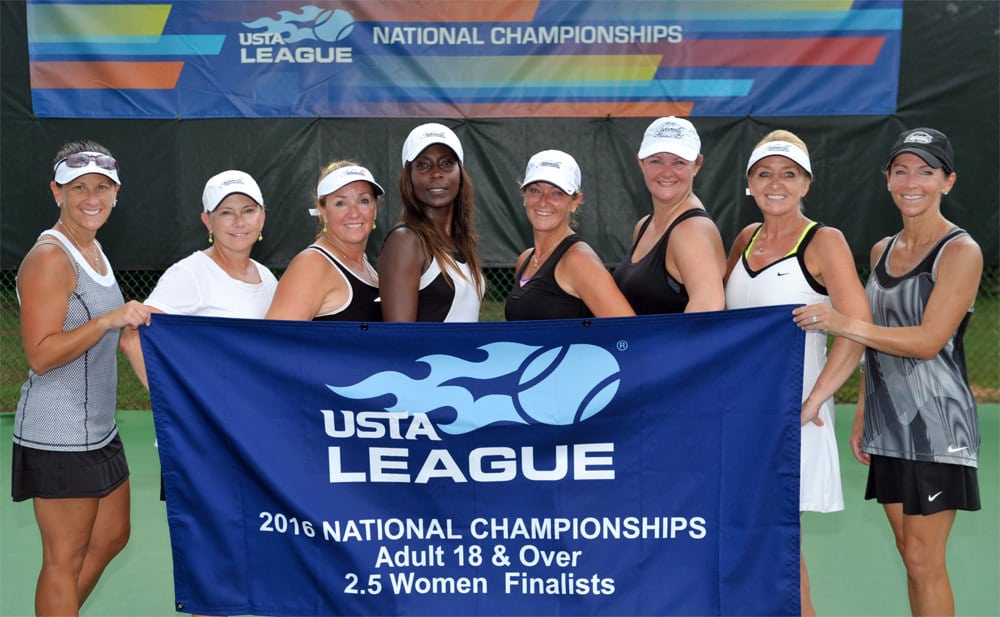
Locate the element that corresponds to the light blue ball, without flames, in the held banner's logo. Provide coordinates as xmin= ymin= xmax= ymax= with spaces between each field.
xmin=514 ymin=344 xmax=621 ymax=425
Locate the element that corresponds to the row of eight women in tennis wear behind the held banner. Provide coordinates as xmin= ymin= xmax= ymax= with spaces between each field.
xmin=12 ymin=117 xmax=983 ymax=615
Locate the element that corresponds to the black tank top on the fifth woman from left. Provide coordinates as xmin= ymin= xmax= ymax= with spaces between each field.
xmin=504 ymin=234 xmax=593 ymax=321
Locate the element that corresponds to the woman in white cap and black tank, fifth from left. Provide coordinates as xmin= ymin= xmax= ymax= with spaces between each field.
xmin=505 ymin=150 xmax=635 ymax=321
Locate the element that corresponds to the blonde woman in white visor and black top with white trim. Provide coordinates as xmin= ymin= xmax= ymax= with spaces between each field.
xmin=267 ymin=161 xmax=385 ymax=321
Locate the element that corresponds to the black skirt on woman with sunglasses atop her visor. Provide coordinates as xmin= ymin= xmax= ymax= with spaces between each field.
xmin=10 ymin=435 xmax=129 ymax=501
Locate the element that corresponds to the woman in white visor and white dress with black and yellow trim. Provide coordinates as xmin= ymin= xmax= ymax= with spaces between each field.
xmin=726 ymin=130 xmax=871 ymax=615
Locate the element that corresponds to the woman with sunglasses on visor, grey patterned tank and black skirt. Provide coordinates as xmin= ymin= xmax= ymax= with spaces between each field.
xmin=11 ymin=141 xmax=149 ymax=615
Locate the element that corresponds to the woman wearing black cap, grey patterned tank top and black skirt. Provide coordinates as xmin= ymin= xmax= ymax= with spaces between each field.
xmin=794 ymin=128 xmax=983 ymax=615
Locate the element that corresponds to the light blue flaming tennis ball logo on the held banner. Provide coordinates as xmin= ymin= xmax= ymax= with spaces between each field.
xmin=327 ymin=342 xmax=621 ymax=435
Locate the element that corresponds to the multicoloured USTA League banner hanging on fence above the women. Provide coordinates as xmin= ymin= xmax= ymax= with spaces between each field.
xmin=27 ymin=0 xmax=902 ymax=118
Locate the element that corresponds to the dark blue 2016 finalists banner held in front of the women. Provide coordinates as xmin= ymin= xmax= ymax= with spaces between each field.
xmin=141 ymin=306 xmax=804 ymax=615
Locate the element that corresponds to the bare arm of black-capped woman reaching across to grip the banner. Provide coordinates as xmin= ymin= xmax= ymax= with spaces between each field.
xmin=794 ymin=236 xmax=983 ymax=360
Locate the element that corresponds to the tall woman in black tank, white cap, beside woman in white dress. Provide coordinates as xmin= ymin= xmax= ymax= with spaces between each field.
xmin=614 ymin=116 xmax=726 ymax=315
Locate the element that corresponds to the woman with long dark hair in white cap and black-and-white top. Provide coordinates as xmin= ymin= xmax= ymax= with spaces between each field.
xmin=378 ymin=122 xmax=485 ymax=321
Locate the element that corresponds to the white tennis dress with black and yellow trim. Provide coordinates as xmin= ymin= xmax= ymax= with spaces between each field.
xmin=726 ymin=223 xmax=844 ymax=512
